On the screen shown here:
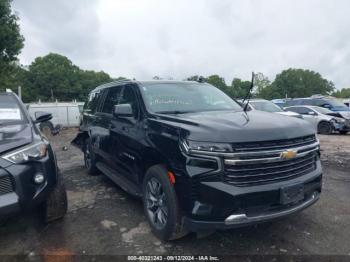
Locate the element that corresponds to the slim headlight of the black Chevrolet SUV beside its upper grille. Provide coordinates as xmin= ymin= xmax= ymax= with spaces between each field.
xmin=183 ymin=140 xmax=232 ymax=153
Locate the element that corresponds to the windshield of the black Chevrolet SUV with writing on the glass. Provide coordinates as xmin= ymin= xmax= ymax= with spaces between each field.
xmin=141 ymin=83 xmax=242 ymax=114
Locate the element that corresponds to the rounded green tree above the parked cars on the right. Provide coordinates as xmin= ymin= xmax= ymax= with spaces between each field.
xmin=260 ymin=68 xmax=334 ymax=99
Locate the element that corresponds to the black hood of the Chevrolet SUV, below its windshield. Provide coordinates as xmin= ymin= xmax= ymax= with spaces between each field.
xmin=155 ymin=110 xmax=315 ymax=143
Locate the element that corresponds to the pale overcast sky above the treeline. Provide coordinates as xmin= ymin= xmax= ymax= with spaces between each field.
xmin=13 ymin=0 xmax=350 ymax=88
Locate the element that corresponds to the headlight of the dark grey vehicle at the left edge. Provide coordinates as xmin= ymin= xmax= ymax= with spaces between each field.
xmin=2 ymin=142 xmax=47 ymax=164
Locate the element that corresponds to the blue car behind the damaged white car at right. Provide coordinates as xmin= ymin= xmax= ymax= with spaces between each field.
xmin=285 ymin=95 xmax=350 ymax=119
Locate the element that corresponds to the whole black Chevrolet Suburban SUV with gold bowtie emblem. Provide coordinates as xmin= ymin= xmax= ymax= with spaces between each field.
xmin=73 ymin=81 xmax=322 ymax=240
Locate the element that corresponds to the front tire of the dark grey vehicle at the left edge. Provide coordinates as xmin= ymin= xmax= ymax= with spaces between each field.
xmin=44 ymin=171 xmax=68 ymax=223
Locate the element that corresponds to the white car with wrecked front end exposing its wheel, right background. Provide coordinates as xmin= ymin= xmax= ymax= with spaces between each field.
xmin=285 ymin=106 xmax=350 ymax=135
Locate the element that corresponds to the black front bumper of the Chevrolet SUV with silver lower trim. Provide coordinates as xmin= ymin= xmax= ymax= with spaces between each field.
xmin=185 ymin=161 xmax=322 ymax=231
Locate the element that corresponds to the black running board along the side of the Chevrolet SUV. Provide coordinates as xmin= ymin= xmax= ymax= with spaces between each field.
xmin=96 ymin=162 xmax=142 ymax=197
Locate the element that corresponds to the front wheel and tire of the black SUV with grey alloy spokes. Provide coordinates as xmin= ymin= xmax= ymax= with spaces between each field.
xmin=142 ymin=165 xmax=188 ymax=241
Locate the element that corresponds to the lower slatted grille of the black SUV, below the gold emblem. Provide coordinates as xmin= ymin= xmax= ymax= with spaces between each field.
xmin=223 ymin=151 xmax=318 ymax=186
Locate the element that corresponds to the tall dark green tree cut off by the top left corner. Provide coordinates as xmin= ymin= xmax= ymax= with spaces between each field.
xmin=0 ymin=0 xmax=24 ymax=90
